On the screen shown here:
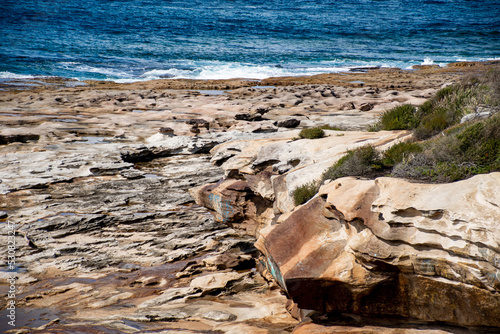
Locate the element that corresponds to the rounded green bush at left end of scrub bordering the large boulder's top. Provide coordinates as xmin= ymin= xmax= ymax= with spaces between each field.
xmin=322 ymin=145 xmax=383 ymax=181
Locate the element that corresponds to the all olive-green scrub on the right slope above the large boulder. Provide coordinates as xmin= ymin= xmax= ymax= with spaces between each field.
xmin=293 ymin=71 xmax=500 ymax=204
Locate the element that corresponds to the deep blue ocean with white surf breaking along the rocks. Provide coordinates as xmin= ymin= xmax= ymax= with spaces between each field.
xmin=0 ymin=0 xmax=500 ymax=82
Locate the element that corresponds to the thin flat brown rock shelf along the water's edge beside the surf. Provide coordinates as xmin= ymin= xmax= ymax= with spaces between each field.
xmin=0 ymin=60 xmax=500 ymax=92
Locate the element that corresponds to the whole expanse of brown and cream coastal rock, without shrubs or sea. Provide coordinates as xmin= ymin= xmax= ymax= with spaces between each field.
xmin=0 ymin=62 xmax=500 ymax=333
